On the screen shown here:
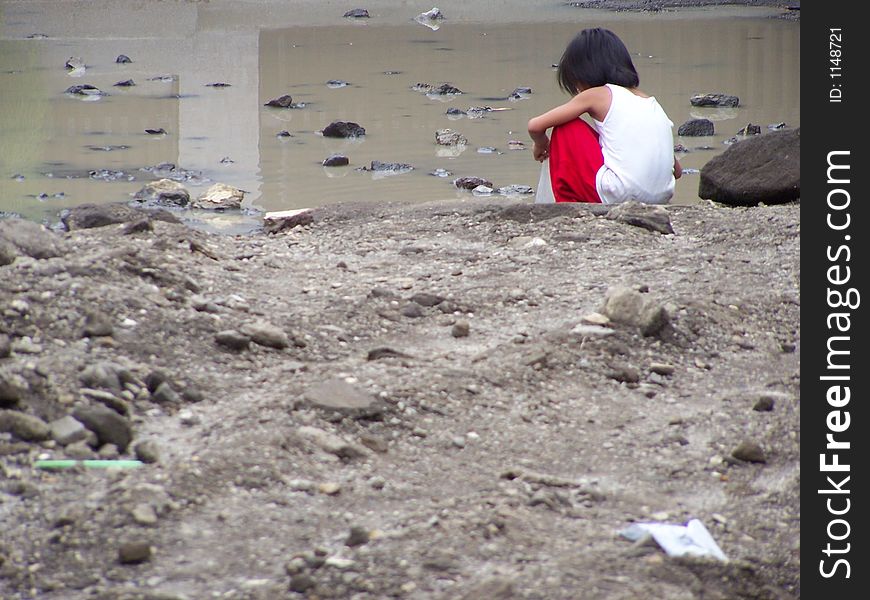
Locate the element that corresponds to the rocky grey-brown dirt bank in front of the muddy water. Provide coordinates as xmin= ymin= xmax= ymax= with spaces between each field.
xmin=0 ymin=200 xmax=800 ymax=600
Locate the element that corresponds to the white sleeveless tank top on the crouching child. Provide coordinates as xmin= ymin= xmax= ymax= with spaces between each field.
xmin=593 ymin=83 xmax=675 ymax=204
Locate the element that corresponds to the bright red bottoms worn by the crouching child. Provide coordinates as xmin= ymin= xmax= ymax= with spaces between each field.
xmin=550 ymin=119 xmax=604 ymax=204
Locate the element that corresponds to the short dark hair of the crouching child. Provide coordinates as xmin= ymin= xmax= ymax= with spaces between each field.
xmin=558 ymin=27 xmax=640 ymax=96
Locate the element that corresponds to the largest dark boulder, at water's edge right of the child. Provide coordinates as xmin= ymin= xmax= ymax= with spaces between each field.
xmin=698 ymin=127 xmax=801 ymax=206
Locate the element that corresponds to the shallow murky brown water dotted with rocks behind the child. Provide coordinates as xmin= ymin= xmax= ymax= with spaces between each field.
xmin=0 ymin=1 xmax=800 ymax=227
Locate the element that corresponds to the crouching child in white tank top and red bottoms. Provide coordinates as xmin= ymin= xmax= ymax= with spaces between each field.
xmin=529 ymin=28 xmax=682 ymax=204
